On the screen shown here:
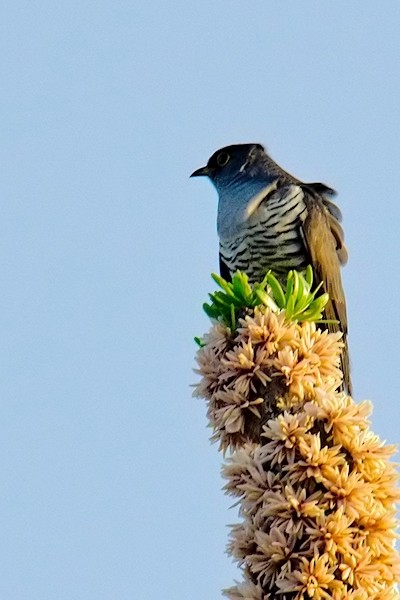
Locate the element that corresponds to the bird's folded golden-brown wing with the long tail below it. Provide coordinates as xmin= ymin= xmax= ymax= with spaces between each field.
xmin=302 ymin=190 xmax=351 ymax=393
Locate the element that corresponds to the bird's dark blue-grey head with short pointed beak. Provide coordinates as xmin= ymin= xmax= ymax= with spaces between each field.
xmin=190 ymin=144 xmax=268 ymax=191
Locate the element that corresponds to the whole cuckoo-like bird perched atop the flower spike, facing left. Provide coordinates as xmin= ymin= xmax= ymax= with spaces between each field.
xmin=191 ymin=144 xmax=351 ymax=393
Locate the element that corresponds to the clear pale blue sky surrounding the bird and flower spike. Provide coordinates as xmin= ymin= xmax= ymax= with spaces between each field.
xmin=0 ymin=0 xmax=400 ymax=600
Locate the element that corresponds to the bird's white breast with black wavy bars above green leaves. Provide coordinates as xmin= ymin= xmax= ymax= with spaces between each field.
xmin=220 ymin=185 xmax=309 ymax=282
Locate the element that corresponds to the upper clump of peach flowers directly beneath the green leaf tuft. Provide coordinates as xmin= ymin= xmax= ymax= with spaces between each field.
xmin=195 ymin=306 xmax=342 ymax=450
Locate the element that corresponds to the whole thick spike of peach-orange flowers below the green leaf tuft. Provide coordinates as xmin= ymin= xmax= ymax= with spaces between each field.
xmin=195 ymin=306 xmax=400 ymax=600
